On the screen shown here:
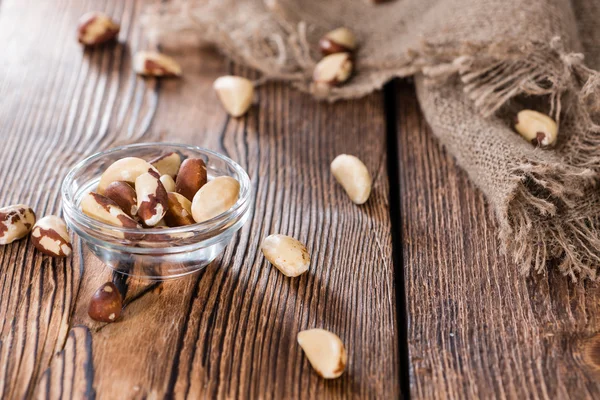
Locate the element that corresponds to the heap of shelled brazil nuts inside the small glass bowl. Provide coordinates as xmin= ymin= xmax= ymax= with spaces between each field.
xmin=81 ymin=152 xmax=240 ymax=229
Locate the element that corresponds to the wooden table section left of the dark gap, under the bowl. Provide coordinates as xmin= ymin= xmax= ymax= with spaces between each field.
xmin=0 ymin=0 xmax=400 ymax=399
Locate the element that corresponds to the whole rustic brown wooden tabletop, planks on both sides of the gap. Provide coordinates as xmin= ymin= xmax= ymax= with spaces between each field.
xmin=0 ymin=0 xmax=600 ymax=399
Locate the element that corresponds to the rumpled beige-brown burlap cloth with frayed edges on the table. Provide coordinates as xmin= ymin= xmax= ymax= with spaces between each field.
xmin=144 ymin=0 xmax=600 ymax=279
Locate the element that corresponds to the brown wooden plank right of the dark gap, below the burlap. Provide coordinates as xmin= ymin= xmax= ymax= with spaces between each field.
xmin=398 ymin=79 xmax=600 ymax=399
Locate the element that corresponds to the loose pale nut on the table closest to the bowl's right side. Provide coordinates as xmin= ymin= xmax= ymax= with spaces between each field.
xmin=260 ymin=234 xmax=310 ymax=277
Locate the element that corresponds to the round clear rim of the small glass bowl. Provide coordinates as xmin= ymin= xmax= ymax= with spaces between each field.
xmin=61 ymin=142 xmax=252 ymax=235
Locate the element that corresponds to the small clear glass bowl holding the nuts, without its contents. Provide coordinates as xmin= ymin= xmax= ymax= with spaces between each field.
xmin=62 ymin=143 xmax=252 ymax=280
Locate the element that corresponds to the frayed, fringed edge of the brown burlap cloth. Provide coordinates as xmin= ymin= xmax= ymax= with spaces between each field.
xmin=144 ymin=6 xmax=600 ymax=280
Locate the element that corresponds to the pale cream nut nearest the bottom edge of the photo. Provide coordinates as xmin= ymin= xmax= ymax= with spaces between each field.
xmin=298 ymin=329 xmax=348 ymax=379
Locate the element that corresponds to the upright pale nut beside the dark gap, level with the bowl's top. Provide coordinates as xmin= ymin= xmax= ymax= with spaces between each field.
xmin=331 ymin=154 xmax=372 ymax=204
